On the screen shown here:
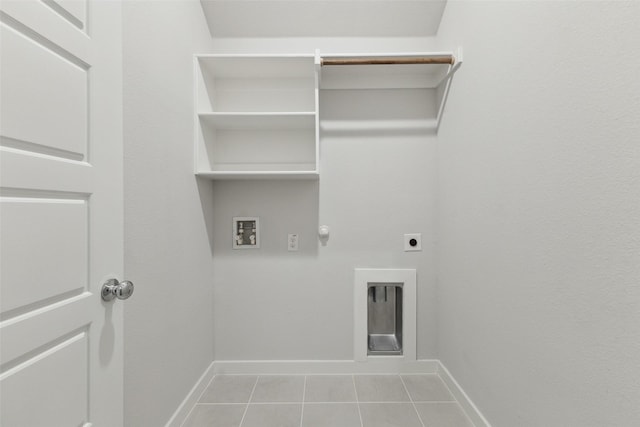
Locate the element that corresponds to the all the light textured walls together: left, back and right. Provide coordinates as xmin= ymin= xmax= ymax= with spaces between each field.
xmin=124 ymin=1 xmax=640 ymax=427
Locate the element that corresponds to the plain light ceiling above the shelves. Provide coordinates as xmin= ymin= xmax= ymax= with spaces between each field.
xmin=200 ymin=0 xmax=446 ymax=38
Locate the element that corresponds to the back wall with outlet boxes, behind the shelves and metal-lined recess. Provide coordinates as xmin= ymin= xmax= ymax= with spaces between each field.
xmin=213 ymin=39 xmax=435 ymax=360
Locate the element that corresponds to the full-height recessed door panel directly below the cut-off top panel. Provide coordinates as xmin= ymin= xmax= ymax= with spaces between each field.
xmin=0 ymin=25 xmax=88 ymax=156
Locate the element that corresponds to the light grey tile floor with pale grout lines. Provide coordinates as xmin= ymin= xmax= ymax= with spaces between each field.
xmin=183 ymin=374 xmax=473 ymax=427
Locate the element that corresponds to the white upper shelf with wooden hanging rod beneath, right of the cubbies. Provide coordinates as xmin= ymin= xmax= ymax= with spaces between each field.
xmin=320 ymin=52 xmax=462 ymax=89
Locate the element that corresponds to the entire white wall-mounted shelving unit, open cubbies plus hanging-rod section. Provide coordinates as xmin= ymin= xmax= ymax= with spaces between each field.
xmin=194 ymin=50 xmax=462 ymax=179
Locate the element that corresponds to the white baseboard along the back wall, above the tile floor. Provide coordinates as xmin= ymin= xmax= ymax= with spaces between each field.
xmin=213 ymin=356 xmax=439 ymax=375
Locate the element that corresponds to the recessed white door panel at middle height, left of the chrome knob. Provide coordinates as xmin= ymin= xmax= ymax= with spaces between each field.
xmin=0 ymin=197 xmax=88 ymax=313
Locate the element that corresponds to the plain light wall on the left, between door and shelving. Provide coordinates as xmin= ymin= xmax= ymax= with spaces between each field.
xmin=123 ymin=1 xmax=213 ymax=427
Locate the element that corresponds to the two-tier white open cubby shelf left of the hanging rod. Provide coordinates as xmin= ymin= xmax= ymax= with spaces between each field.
xmin=195 ymin=55 xmax=318 ymax=179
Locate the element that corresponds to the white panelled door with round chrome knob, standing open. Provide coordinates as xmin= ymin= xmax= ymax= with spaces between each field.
xmin=0 ymin=0 xmax=126 ymax=427
